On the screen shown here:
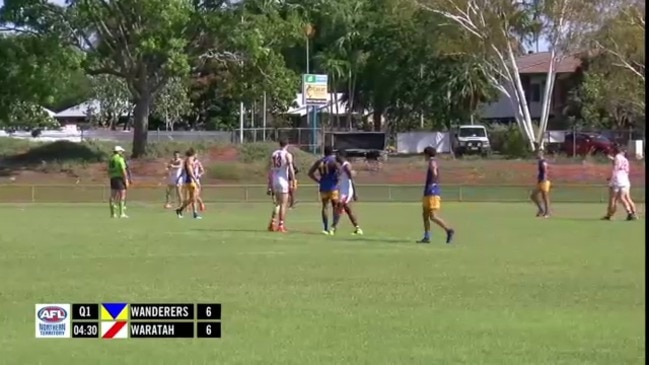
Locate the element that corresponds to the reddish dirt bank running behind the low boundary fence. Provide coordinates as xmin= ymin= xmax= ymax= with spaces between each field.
xmin=0 ymin=147 xmax=645 ymax=185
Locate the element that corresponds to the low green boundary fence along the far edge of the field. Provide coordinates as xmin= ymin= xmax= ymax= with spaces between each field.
xmin=0 ymin=184 xmax=645 ymax=203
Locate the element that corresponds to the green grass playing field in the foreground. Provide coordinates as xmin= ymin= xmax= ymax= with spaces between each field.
xmin=0 ymin=203 xmax=645 ymax=365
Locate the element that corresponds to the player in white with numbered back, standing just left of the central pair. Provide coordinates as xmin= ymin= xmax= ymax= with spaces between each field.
xmin=268 ymin=140 xmax=295 ymax=232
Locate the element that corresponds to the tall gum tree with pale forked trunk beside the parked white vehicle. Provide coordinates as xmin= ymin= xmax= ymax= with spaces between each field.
xmin=419 ymin=0 xmax=604 ymax=149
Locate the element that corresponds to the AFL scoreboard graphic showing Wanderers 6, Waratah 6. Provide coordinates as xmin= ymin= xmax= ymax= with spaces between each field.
xmin=35 ymin=302 xmax=221 ymax=339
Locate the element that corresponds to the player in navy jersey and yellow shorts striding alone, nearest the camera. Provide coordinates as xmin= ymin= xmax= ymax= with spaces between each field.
xmin=417 ymin=146 xmax=455 ymax=243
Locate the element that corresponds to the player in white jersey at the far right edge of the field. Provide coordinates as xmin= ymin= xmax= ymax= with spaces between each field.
xmin=604 ymin=146 xmax=637 ymax=220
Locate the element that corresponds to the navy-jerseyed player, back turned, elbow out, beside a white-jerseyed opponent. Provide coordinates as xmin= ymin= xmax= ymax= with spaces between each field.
xmin=308 ymin=146 xmax=340 ymax=235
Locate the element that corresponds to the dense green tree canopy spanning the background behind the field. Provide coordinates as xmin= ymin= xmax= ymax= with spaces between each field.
xmin=0 ymin=0 xmax=644 ymax=157
